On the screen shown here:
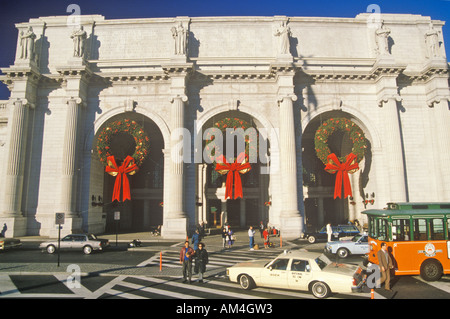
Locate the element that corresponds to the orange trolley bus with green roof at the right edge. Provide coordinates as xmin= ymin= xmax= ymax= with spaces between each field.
xmin=362 ymin=203 xmax=450 ymax=281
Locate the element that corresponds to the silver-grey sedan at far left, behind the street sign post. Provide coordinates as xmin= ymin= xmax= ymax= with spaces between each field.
xmin=39 ymin=234 xmax=109 ymax=255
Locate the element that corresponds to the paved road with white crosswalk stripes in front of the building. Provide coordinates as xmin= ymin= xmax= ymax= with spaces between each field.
xmin=0 ymin=232 xmax=450 ymax=300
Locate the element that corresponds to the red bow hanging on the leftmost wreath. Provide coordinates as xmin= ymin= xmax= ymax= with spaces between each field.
xmin=105 ymin=156 xmax=139 ymax=202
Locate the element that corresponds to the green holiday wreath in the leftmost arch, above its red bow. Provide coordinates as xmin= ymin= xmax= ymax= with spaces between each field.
xmin=97 ymin=119 xmax=150 ymax=166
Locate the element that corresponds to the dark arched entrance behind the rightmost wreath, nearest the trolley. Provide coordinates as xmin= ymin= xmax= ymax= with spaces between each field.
xmin=302 ymin=111 xmax=372 ymax=231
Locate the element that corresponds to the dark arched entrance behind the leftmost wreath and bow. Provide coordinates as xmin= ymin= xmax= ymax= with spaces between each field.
xmin=90 ymin=112 xmax=164 ymax=232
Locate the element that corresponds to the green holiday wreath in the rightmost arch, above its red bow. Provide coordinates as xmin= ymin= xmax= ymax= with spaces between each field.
xmin=314 ymin=118 xmax=367 ymax=165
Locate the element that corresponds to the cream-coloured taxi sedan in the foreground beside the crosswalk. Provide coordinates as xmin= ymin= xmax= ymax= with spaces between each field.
xmin=227 ymin=251 xmax=363 ymax=298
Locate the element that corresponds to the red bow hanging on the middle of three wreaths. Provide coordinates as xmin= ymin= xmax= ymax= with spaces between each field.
xmin=216 ymin=153 xmax=252 ymax=199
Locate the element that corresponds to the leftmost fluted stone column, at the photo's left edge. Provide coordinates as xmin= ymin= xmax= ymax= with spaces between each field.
xmin=1 ymin=99 xmax=29 ymax=217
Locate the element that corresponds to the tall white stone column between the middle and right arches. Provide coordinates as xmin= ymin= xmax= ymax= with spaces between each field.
xmin=279 ymin=94 xmax=302 ymax=238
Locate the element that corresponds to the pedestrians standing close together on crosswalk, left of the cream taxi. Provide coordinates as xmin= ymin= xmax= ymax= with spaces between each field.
xmin=180 ymin=230 xmax=208 ymax=283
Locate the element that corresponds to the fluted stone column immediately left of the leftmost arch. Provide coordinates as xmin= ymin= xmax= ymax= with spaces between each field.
xmin=59 ymin=98 xmax=82 ymax=217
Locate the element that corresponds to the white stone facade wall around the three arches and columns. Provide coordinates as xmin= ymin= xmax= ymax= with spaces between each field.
xmin=0 ymin=14 xmax=450 ymax=235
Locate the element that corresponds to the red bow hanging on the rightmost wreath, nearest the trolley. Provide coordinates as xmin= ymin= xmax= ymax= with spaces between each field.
xmin=325 ymin=153 xmax=359 ymax=199
